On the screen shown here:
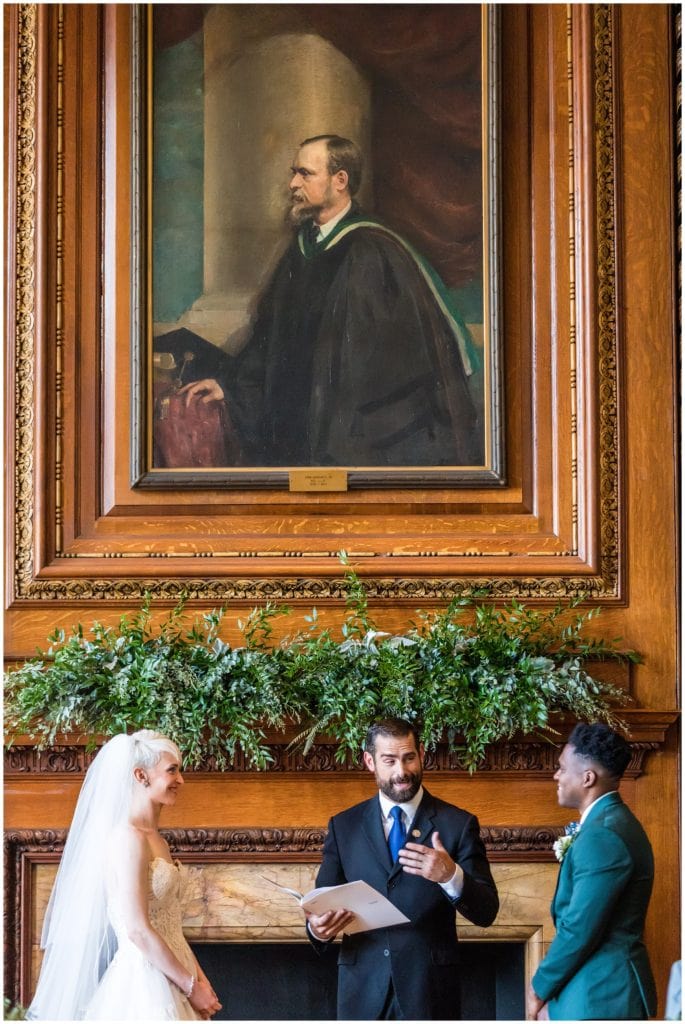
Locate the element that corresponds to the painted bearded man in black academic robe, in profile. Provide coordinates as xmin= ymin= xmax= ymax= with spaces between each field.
xmin=176 ymin=135 xmax=484 ymax=467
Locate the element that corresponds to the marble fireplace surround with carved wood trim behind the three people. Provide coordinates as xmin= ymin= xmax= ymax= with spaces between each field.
xmin=4 ymin=825 xmax=562 ymax=1005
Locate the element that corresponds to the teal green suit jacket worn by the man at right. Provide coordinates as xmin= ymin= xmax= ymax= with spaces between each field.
xmin=532 ymin=793 xmax=656 ymax=1020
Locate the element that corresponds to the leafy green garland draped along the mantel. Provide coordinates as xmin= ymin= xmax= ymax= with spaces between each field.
xmin=5 ymin=568 xmax=640 ymax=771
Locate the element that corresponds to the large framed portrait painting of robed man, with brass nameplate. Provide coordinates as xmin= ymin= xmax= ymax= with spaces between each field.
xmin=132 ymin=3 xmax=505 ymax=492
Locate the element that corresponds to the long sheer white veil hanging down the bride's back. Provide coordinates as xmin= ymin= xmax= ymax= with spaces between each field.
xmin=28 ymin=734 xmax=138 ymax=1020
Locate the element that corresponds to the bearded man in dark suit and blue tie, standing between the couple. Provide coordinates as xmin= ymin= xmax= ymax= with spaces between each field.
xmin=307 ymin=719 xmax=499 ymax=1020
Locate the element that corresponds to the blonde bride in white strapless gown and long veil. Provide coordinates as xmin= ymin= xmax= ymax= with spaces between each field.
xmin=28 ymin=729 xmax=221 ymax=1020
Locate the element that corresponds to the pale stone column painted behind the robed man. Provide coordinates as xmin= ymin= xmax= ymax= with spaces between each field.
xmin=178 ymin=4 xmax=371 ymax=351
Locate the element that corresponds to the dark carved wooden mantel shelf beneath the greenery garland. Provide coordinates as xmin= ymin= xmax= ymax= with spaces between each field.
xmin=4 ymin=709 xmax=679 ymax=779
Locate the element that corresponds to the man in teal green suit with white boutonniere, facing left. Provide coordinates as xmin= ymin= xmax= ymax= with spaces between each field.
xmin=527 ymin=725 xmax=656 ymax=1020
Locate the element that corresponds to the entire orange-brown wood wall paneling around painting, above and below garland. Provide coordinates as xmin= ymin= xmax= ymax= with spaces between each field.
xmin=5 ymin=4 xmax=680 ymax=1011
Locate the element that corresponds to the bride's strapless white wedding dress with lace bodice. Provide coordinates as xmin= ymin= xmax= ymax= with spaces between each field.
xmin=85 ymin=857 xmax=200 ymax=1021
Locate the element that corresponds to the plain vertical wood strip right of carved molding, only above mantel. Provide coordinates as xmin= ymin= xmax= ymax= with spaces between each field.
xmin=619 ymin=5 xmax=679 ymax=707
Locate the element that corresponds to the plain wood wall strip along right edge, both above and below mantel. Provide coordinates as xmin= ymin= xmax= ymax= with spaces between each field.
xmin=607 ymin=5 xmax=681 ymax=1013
